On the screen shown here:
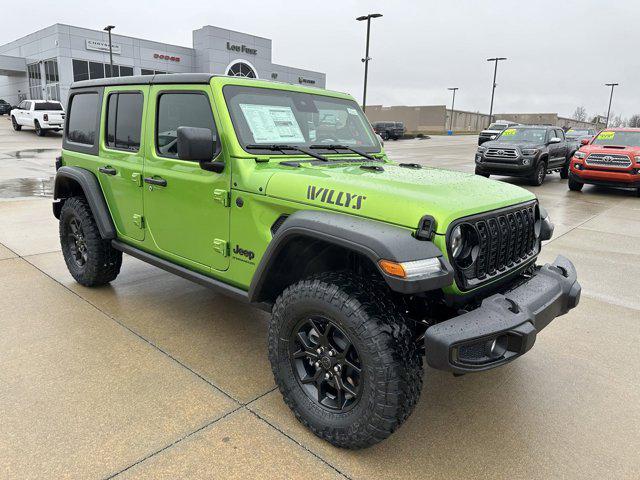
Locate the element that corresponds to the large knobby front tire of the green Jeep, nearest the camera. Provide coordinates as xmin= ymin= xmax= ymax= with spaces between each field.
xmin=269 ymin=272 xmax=423 ymax=449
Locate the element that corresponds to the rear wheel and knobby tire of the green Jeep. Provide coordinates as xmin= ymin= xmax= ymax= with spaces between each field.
xmin=60 ymin=197 xmax=122 ymax=287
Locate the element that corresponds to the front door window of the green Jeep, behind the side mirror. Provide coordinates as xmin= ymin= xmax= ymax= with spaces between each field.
xmin=156 ymin=93 xmax=217 ymax=158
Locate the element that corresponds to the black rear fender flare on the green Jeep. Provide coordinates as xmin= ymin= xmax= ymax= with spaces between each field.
xmin=53 ymin=167 xmax=116 ymax=240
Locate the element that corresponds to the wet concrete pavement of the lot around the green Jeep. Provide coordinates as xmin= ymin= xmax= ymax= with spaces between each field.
xmin=0 ymin=117 xmax=640 ymax=479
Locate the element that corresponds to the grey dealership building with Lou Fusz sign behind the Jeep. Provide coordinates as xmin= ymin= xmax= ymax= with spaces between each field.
xmin=0 ymin=24 xmax=326 ymax=105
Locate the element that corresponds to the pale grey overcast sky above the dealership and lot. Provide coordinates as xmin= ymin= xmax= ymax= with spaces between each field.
xmin=5 ymin=0 xmax=640 ymax=117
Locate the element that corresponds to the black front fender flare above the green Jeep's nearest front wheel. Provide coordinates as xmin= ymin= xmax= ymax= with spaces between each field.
xmin=249 ymin=210 xmax=454 ymax=302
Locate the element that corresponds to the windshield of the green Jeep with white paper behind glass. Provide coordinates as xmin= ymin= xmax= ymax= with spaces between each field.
xmin=223 ymin=85 xmax=380 ymax=153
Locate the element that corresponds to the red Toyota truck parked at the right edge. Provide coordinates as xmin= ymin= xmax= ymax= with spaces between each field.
xmin=569 ymin=128 xmax=640 ymax=196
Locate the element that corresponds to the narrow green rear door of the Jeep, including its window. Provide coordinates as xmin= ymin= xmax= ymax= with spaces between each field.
xmin=97 ymin=87 xmax=149 ymax=240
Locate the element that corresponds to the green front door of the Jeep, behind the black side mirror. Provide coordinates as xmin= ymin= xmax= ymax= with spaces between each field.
xmin=144 ymin=85 xmax=231 ymax=270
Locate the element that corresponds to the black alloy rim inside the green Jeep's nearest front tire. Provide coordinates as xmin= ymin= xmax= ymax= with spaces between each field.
xmin=289 ymin=315 xmax=362 ymax=412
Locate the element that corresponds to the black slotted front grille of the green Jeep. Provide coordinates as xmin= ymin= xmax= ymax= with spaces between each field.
xmin=449 ymin=201 xmax=539 ymax=290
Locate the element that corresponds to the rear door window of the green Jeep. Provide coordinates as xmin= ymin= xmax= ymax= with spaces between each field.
xmin=105 ymin=92 xmax=144 ymax=152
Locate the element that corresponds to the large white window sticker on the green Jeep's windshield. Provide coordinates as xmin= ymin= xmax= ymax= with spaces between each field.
xmin=240 ymin=103 xmax=305 ymax=143
